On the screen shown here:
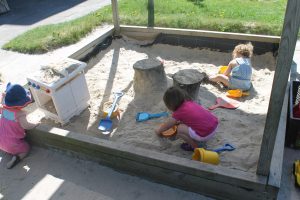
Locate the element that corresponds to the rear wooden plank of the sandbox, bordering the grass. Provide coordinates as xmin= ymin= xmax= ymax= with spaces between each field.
xmin=120 ymin=25 xmax=280 ymax=44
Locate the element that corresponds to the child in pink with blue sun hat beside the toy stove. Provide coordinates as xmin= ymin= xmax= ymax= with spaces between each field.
xmin=0 ymin=83 xmax=37 ymax=169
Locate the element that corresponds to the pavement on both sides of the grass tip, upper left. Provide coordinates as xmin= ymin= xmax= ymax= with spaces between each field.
xmin=0 ymin=0 xmax=111 ymax=85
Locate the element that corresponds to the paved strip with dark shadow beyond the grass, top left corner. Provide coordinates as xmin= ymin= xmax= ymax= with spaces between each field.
xmin=0 ymin=0 xmax=111 ymax=46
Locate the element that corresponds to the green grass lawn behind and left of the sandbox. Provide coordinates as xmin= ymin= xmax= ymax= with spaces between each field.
xmin=3 ymin=0 xmax=287 ymax=54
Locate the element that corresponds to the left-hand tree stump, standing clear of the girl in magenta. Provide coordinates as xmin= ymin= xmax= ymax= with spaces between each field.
xmin=133 ymin=59 xmax=167 ymax=96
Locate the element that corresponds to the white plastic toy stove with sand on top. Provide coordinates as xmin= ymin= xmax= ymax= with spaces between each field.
xmin=27 ymin=58 xmax=90 ymax=124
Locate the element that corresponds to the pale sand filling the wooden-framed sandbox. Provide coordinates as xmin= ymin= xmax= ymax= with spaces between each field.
xmin=36 ymin=37 xmax=275 ymax=173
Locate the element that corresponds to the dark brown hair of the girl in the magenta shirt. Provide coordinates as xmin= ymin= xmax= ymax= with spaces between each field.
xmin=163 ymin=86 xmax=191 ymax=111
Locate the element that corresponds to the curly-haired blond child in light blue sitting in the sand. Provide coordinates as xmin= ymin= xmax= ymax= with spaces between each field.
xmin=209 ymin=42 xmax=253 ymax=90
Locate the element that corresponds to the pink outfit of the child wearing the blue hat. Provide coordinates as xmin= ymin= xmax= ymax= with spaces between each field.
xmin=0 ymin=108 xmax=34 ymax=155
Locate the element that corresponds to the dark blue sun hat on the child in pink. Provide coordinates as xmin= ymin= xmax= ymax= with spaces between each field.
xmin=4 ymin=83 xmax=31 ymax=108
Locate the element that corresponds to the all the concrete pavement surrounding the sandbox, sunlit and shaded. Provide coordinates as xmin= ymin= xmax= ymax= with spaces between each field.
xmin=0 ymin=0 xmax=300 ymax=200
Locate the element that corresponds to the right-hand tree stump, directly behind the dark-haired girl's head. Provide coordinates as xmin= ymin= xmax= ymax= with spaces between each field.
xmin=172 ymin=69 xmax=204 ymax=101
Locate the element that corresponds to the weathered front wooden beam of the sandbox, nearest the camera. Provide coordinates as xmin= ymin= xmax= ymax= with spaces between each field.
xmin=29 ymin=125 xmax=267 ymax=191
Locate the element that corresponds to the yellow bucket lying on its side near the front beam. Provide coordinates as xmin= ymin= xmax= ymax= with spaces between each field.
xmin=192 ymin=148 xmax=220 ymax=165
